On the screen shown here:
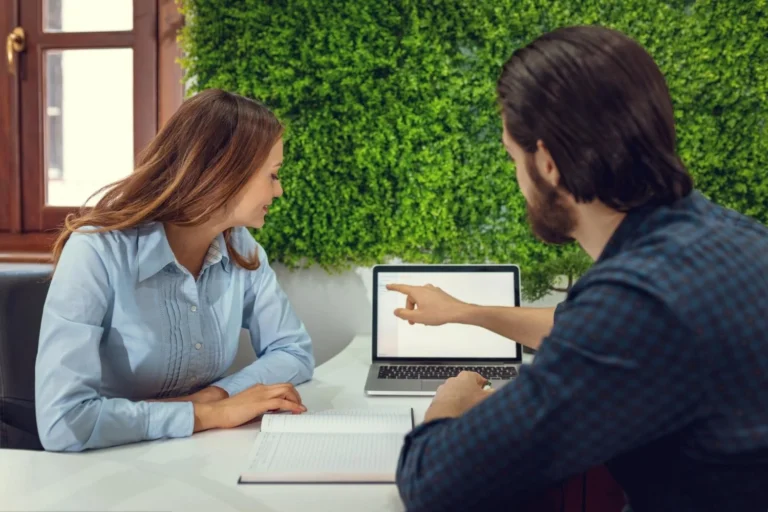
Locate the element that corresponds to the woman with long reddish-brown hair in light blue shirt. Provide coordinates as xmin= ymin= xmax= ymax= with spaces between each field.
xmin=35 ymin=90 xmax=314 ymax=451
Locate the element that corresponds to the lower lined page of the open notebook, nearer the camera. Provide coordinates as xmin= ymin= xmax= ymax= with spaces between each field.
xmin=240 ymin=432 xmax=404 ymax=483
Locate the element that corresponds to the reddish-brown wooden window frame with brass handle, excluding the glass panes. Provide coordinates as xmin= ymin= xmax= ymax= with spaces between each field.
xmin=0 ymin=0 xmax=184 ymax=262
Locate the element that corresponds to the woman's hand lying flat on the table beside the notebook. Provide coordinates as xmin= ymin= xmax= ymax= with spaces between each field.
xmin=194 ymin=384 xmax=307 ymax=432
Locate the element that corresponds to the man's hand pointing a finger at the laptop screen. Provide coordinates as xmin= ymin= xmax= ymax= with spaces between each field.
xmin=387 ymin=284 xmax=472 ymax=325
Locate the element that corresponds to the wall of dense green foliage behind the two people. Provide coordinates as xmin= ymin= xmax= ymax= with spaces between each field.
xmin=176 ymin=0 xmax=768 ymax=300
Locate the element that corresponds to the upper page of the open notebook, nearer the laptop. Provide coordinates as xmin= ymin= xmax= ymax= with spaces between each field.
xmin=261 ymin=408 xmax=413 ymax=434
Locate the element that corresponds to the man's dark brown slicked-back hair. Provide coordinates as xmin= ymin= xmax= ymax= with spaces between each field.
xmin=497 ymin=26 xmax=693 ymax=211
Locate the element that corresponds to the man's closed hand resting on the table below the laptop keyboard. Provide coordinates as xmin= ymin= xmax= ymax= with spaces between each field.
xmin=424 ymin=372 xmax=493 ymax=422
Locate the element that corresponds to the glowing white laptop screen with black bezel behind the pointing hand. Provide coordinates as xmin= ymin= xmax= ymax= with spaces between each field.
xmin=375 ymin=265 xmax=521 ymax=361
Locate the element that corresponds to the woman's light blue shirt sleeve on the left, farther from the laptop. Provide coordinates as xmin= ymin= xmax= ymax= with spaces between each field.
xmin=35 ymin=233 xmax=194 ymax=451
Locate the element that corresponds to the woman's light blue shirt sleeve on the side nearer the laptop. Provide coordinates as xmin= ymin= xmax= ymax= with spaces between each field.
xmin=214 ymin=239 xmax=315 ymax=396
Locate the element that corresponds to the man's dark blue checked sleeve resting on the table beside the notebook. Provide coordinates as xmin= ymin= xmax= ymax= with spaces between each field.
xmin=397 ymin=279 xmax=703 ymax=511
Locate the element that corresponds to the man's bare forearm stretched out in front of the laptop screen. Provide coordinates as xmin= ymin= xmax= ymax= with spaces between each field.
xmin=456 ymin=304 xmax=555 ymax=350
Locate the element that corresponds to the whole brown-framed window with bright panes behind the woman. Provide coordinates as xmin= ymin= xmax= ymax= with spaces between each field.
xmin=0 ymin=0 xmax=183 ymax=253
